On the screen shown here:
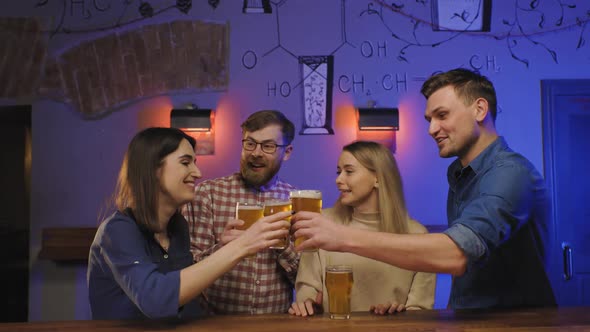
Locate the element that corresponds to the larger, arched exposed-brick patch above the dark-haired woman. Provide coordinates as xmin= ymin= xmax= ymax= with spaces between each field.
xmin=42 ymin=21 xmax=229 ymax=117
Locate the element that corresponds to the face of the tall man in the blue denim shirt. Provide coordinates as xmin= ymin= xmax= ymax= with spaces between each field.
xmin=424 ymin=85 xmax=480 ymax=165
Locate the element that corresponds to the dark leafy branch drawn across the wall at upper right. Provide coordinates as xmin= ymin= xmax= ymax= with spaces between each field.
xmin=368 ymin=0 xmax=590 ymax=68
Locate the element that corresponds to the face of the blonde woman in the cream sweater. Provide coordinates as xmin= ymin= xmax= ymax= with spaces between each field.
xmin=336 ymin=151 xmax=379 ymax=212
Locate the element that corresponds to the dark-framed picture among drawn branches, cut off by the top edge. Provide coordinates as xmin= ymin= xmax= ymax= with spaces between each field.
xmin=431 ymin=0 xmax=492 ymax=31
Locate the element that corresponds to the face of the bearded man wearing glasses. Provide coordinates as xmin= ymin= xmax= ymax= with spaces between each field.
xmin=240 ymin=124 xmax=293 ymax=187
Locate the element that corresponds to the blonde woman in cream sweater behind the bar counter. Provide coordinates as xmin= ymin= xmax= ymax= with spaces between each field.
xmin=289 ymin=141 xmax=436 ymax=316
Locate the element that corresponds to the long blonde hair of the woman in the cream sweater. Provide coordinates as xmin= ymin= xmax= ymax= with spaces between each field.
xmin=333 ymin=141 xmax=409 ymax=234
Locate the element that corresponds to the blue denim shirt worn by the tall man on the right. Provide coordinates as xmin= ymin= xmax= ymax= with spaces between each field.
xmin=445 ymin=137 xmax=556 ymax=309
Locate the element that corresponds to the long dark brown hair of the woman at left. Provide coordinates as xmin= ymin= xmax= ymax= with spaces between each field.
xmin=114 ymin=127 xmax=196 ymax=232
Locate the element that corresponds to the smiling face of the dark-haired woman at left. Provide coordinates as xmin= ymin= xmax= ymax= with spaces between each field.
xmin=158 ymin=139 xmax=201 ymax=208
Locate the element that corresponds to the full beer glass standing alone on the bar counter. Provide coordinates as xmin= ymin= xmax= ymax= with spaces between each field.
xmin=326 ymin=265 xmax=353 ymax=319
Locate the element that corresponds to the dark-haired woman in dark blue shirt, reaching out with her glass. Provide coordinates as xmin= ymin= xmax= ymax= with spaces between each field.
xmin=88 ymin=128 xmax=290 ymax=319
